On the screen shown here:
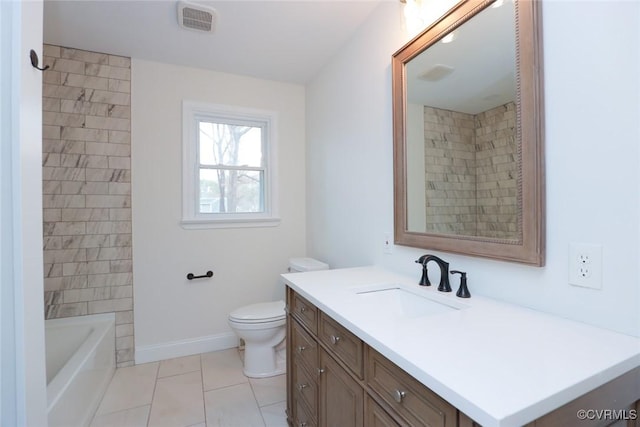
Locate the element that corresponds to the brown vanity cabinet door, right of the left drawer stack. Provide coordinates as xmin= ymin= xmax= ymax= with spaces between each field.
xmin=319 ymin=350 xmax=364 ymax=427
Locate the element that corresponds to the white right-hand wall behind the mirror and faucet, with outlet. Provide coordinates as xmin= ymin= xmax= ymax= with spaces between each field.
xmin=307 ymin=0 xmax=640 ymax=336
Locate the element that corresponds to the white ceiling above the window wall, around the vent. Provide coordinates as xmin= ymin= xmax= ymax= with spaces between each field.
xmin=44 ymin=0 xmax=390 ymax=84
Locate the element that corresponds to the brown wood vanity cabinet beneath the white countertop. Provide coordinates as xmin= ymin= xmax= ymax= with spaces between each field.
xmin=287 ymin=288 xmax=640 ymax=427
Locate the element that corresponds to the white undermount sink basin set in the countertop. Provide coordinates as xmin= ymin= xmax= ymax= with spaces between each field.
xmin=356 ymin=287 xmax=461 ymax=318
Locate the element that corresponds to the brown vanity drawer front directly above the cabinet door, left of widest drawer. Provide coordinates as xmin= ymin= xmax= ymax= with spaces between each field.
xmin=318 ymin=313 xmax=364 ymax=378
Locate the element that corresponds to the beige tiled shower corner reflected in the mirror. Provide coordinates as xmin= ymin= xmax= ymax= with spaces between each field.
xmin=424 ymin=102 xmax=519 ymax=239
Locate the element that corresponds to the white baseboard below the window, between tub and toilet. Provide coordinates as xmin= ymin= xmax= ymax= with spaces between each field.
xmin=135 ymin=332 xmax=238 ymax=365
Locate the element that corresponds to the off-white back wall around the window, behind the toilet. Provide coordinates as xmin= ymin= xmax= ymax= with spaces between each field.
xmin=131 ymin=59 xmax=305 ymax=363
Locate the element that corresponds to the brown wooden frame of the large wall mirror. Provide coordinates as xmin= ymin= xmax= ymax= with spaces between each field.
xmin=392 ymin=0 xmax=545 ymax=266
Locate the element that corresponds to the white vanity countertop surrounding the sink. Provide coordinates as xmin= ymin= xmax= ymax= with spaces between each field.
xmin=282 ymin=267 xmax=640 ymax=427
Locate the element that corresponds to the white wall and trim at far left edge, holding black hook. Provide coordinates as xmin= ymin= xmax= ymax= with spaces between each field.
xmin=0 ymin=1 xmax=47 ymax=426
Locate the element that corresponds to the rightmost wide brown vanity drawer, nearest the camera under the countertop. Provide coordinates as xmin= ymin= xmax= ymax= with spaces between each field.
xmin=366 ymin=347 xmax=457 ymax=427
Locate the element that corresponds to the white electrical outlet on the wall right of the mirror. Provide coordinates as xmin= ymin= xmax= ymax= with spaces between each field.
xmin=569 ymin=243 xmax=602 ymax=289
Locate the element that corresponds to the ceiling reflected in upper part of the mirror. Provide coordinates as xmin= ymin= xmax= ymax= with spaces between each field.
xmin=406 ymin=1 xmax=516 ymax=114
